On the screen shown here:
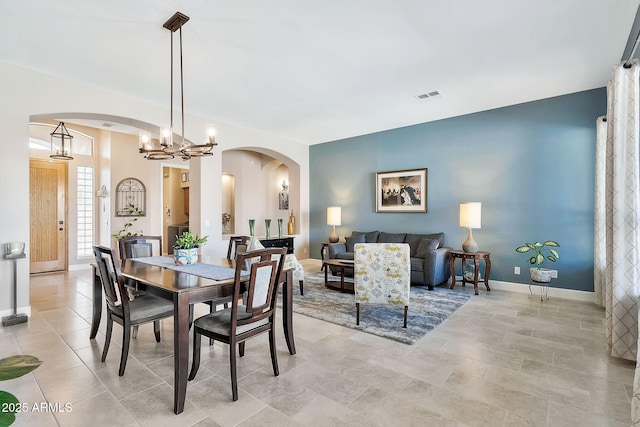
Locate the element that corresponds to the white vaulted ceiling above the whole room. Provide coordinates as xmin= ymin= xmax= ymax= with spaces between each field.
xmin=0 ymin=0 xmax=640 ymax=144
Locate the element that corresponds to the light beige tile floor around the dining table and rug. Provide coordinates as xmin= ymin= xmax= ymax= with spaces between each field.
xmin=0 ymin=260 xmax=634 ymax=427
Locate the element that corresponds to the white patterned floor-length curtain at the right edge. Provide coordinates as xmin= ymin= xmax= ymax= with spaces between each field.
xmin=594 ymin=60 xmax=640 ymax=425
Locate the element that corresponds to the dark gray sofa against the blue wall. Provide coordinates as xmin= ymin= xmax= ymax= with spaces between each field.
xmin=328 ymin=230 xmax=451 ymax=290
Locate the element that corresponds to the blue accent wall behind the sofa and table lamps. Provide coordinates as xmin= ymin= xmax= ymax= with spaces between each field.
xmin=309 ymin=88 xmax=606 ymax=291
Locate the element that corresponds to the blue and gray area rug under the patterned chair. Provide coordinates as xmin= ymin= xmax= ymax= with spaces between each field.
xmin=293 ymin=273 xmax=471 ymax=344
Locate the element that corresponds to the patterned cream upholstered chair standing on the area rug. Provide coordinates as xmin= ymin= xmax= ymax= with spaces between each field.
xmin=353 ymin=243 xmax=411 ymax=328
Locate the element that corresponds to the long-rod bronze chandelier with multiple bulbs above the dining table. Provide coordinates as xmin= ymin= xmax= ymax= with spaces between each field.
xmin=138 ymin=12 xmax=218 ymax=160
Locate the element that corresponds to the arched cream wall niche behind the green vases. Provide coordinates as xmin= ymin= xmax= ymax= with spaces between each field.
xmin=222 ymin=147 xmax=301 ymax=241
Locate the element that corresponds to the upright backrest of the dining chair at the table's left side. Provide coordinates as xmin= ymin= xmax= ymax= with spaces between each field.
xmin=93 ymin=246 xmax=129 ymax=312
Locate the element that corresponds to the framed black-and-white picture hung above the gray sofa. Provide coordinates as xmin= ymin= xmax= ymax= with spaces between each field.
xmin=376 ymin=168 xmax=427 ymax=212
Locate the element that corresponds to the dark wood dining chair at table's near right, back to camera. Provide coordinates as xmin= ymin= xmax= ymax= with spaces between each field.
xmin=189 ymin=248 xmax=287 ymax=401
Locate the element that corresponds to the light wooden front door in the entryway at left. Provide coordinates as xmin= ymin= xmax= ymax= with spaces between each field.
xmin=29 ymin=159 xmax=67 ymax=274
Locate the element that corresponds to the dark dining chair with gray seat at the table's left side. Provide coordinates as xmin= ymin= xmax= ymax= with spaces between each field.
xmin=93 ymin=246 xmax=173 ymax=376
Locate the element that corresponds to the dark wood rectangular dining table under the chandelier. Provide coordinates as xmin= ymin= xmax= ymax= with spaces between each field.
xmin=90 ymin=256 xmax=296 ymax=414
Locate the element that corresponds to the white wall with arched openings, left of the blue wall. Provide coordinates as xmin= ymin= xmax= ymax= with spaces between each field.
xmin=0 ymin=63 xmax=309 ymax=315
